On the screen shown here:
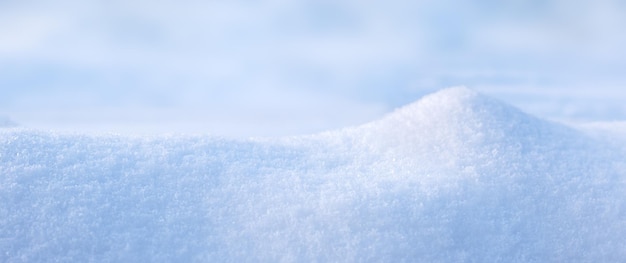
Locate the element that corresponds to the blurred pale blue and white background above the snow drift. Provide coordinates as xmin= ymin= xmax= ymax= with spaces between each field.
xmin=0 ymin=0 xmax=626 ymax=137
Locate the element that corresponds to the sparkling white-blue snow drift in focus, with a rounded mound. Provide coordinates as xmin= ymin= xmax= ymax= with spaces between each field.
xmin=0 ymin=88 xmax=626 ymax=262
